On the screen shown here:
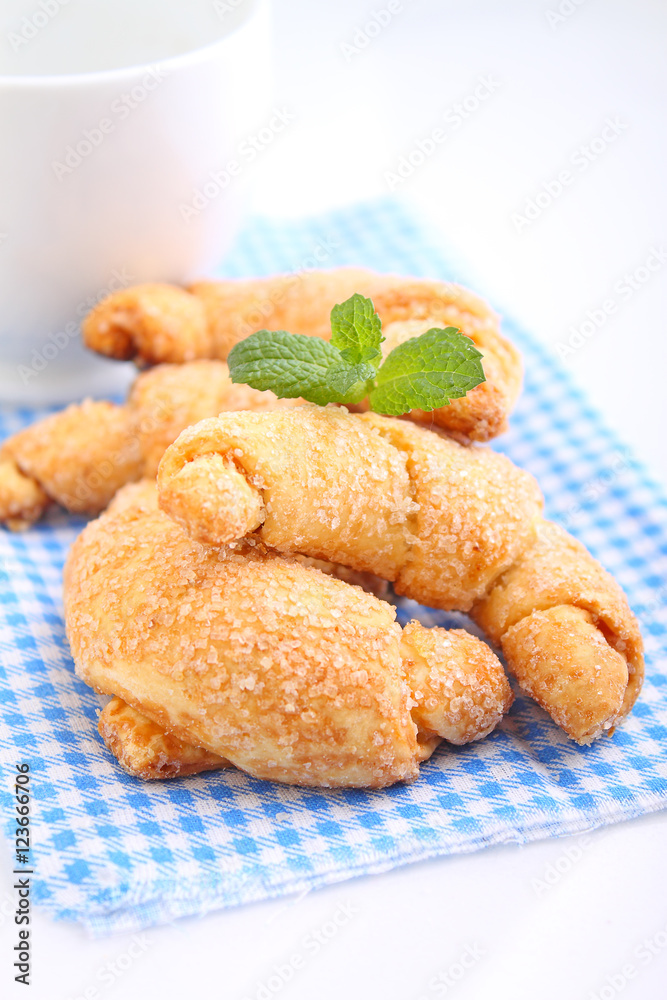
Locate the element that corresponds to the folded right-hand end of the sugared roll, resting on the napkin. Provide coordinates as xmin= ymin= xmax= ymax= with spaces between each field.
xmin=472 ymin=521 xmax=644 ymax=743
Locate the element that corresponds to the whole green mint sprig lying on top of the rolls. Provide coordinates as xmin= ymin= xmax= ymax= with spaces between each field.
xmin=227 ymin=294 xmax=485 ymax=416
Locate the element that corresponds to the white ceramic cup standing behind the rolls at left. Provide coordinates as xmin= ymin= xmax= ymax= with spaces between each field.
xmin=0 ymin=0 xmax=272 ymax=403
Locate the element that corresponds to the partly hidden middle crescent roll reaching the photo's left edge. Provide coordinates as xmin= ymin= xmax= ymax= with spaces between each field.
xmin=0 ymin=361 xmax=300 ymax=529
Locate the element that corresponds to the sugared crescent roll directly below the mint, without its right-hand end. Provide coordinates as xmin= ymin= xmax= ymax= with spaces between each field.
xmin=158 ymin=405 xmax=542 ymax=611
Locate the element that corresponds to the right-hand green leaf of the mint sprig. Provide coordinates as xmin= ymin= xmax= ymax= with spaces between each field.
xmin=369 ymin=326 xmax=484 ymax=416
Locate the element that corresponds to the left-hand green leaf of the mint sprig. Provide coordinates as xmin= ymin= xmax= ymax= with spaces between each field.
xmin=227 ymin=330 xmax=375 ymax=406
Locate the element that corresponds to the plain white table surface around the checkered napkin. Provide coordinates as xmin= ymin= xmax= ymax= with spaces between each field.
xmin=0 ymin=0 xmax=667 ymax=1000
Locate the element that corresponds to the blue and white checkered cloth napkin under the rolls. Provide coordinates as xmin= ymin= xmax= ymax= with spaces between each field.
xmin=0 ymin=201 xmax=667 ymax=934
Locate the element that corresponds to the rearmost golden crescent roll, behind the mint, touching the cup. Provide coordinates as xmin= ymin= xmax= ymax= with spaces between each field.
xmin=83 ymin=268 xmax=521 ymax=441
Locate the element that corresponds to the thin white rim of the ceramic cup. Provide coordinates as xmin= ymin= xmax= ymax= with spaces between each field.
xmin=0 ymin=0 xmax=267 ymax=89
